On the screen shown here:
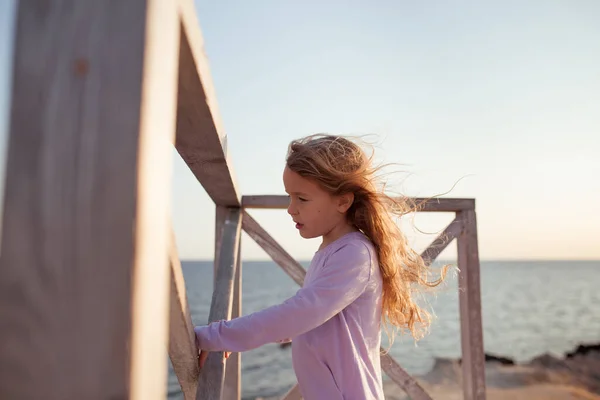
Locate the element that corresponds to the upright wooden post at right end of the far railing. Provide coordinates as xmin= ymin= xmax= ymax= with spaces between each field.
xmin=457 ymin=210 xmax=486 ymax=400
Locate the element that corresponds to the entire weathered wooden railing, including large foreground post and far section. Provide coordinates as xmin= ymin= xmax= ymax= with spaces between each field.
xmin=0 ymin=0 xmax=485 ymax=400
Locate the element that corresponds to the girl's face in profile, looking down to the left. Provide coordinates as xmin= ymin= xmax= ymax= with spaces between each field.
xmin=283 ymin=167 xmax=353 ymax=244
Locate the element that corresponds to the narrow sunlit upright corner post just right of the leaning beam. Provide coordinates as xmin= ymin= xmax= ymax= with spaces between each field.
xmin=222 ymin=238 xmax=242 ymax=400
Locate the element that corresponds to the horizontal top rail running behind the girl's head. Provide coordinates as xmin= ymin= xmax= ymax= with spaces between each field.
xmin=242 ymin=195 xmax=475 ymax=212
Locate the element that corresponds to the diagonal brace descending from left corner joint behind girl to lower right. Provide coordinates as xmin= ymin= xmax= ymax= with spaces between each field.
xmin=242 ymin=211 xmax=431 ymax=400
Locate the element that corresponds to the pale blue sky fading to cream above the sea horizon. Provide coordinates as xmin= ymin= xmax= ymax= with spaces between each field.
xmin=0 ymin=0 xmax=600 ymax=260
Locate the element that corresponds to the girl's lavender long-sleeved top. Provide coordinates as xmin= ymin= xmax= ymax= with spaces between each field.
xmin=195 ymin=232 xmax=384 ymax=400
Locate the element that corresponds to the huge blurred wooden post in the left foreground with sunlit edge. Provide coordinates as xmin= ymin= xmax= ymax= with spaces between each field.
xmin=0 ymin=0 xmax=179 ymax=400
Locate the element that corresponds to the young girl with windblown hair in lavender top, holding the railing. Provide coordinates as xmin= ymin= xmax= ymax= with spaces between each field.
xmin=195 ymin=135 xmax=436 ymax=400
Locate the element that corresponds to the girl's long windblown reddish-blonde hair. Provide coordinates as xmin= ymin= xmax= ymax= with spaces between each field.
xmin=286 ymin=134 xmax=447 ymax=342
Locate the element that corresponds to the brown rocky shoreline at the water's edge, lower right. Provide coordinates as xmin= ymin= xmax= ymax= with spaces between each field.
xmin=257 ymin=344 xmax=600 ymax=400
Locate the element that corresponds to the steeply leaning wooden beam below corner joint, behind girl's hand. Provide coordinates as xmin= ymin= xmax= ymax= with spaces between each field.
xmin=196 ymin=208 xmax=242 ymax=400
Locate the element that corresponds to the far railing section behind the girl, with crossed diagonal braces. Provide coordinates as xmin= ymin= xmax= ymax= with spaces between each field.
xmin=237 ymin=196 xmax=485 ymax=399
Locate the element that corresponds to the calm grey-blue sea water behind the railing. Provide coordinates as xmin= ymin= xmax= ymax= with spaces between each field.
xmin=168 ymin=261 xmax=600 ymax=400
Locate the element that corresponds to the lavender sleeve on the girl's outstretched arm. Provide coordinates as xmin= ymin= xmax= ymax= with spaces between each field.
xmin=194 ymin=243 xmax=371 ymax=352
